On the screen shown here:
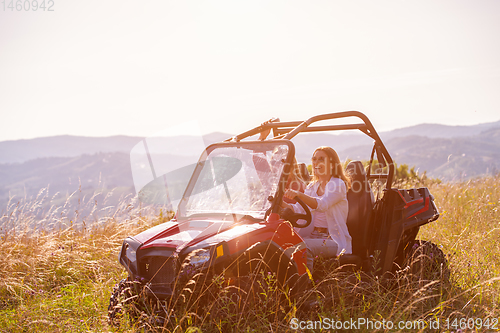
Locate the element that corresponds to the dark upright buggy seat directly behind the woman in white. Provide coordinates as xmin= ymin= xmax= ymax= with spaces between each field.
xmin=339 ymin=161 xmax=375 ymax=268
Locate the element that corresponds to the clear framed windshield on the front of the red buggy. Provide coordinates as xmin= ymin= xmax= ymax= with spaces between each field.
xmin=178 ymin=142 xmax=289 ymax=219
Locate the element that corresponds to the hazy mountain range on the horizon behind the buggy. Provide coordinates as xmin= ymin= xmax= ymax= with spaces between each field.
xmin=0 ymin=121 xmax=500 ymax=210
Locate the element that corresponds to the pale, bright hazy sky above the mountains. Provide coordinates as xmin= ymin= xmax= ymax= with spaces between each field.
xmin=0 ymin=0 xmax=500 ymax=141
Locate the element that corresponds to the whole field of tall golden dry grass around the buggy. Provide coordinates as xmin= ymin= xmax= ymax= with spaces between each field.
xmin=0 ymin=177 xmax=500 ymax=332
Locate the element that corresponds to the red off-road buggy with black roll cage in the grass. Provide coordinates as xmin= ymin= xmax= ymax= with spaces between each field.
xmin=109 ymin=111 xmax=439 ymax=322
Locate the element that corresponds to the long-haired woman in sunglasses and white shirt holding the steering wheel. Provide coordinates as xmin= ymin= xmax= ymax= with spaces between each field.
xmin=282 ymin=147 xmax=352 ymax=271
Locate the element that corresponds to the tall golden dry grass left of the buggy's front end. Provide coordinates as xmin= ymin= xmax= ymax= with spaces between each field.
xmin=0 ymin=189 xmax=165 ymax=332
